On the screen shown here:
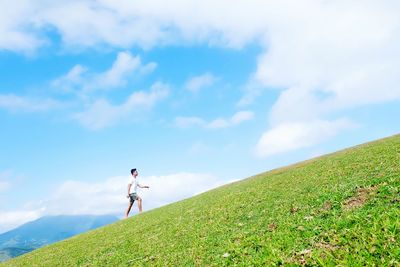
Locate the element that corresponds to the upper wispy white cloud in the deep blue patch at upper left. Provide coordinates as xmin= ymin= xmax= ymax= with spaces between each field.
xmin=52 ymin=51 xmax=157 ymax=94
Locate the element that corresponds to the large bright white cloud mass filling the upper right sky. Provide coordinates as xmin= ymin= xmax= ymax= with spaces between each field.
xmin=231 ymin=1 xmax=400 ymax=156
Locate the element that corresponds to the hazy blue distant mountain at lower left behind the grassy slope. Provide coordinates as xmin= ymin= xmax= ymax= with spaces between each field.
xmin=0 ymin=215 xmax=118 ymax=262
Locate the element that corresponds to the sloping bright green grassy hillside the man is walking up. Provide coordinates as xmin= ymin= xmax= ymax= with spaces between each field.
xmin=0 ymin=135 xmax=400 ymax=266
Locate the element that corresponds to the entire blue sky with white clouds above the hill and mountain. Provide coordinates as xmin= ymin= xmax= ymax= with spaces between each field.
xmin=0 ymin=0 xmax=400 ymax=232
